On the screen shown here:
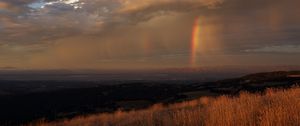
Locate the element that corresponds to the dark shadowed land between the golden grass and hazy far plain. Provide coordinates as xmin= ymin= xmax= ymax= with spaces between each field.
xmin=0 ymin=71 xmax=300 ymax=125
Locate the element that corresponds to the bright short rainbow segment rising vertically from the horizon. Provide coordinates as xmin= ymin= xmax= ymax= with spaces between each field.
xmin=190 ymin=17 xmax=200 ymax=66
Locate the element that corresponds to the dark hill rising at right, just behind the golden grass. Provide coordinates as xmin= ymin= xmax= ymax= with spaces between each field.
xmin=200 ymin=71 xmax=300 ymax=94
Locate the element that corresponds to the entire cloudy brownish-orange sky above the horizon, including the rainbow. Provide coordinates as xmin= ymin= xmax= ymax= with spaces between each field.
xmin=0 ymin=0 xmax=300 ymax=69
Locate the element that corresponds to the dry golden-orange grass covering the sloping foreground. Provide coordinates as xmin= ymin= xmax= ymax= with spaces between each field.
xmin=33 ymin=87 xmax=300 ymax=126
